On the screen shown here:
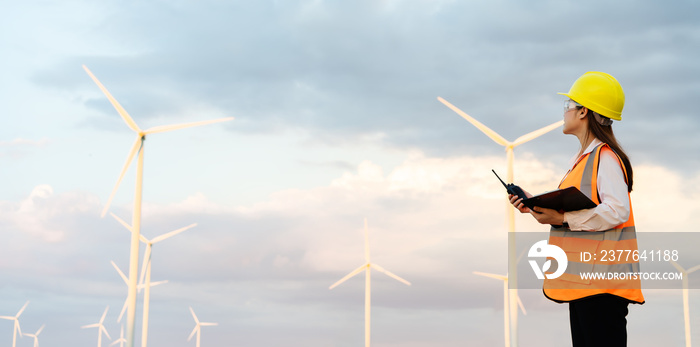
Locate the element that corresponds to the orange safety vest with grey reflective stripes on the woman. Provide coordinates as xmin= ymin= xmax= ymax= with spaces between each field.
xmin=543 ymin=143 xmax=644 ymax=304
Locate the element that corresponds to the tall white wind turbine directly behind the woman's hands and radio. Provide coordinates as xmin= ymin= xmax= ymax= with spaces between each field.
xmin=438 ymin=96 xmax=564 ymax=347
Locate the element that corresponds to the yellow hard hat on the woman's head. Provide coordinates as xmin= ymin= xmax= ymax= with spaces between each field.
xmin=557 ymin=71 xmax=625 ymax=120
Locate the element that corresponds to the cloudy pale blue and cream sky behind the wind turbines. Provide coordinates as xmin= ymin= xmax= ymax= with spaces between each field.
xmin=0 ymin=0 xmax=700 ymax=347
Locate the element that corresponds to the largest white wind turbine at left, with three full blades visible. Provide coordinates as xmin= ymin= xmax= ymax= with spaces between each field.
xmin=83 ymin=65 xmax=233 ymax=347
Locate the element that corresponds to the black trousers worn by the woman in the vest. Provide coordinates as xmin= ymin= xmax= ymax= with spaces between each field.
xmin=569 ymin=294 xmax=629 ymax=347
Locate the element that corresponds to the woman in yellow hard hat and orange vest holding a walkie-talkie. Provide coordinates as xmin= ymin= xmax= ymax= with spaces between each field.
xmin=509 ymin=72 xmax=644 ymax=347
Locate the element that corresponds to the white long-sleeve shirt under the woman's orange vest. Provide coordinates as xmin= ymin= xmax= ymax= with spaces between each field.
xmin=564 ymin=139 xmax=630 ymax=231
